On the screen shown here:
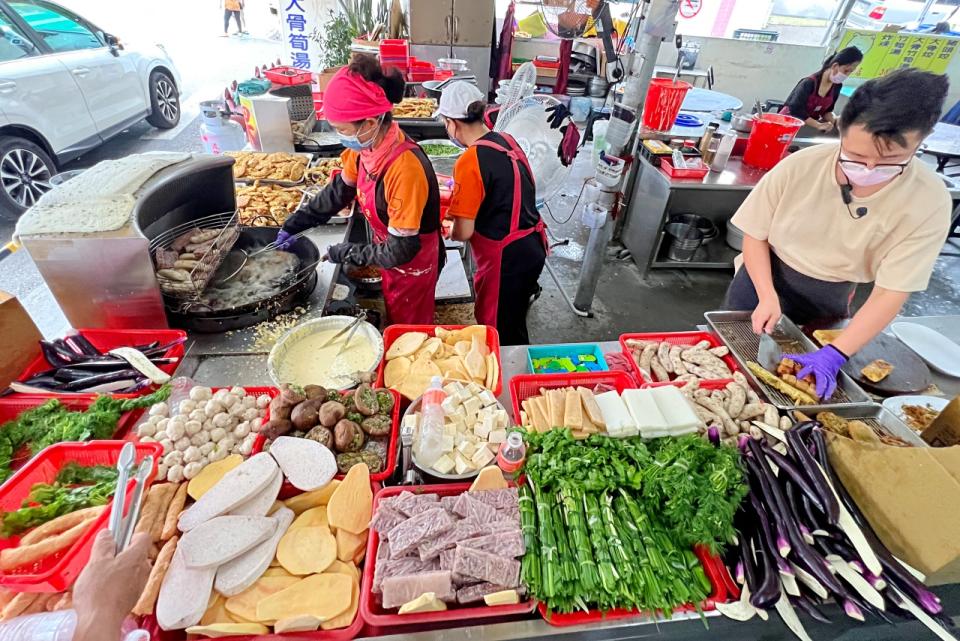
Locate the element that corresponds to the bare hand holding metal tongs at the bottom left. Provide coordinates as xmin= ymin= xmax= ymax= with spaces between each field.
xmin=73 ymin=530 xmax=150 ymax=640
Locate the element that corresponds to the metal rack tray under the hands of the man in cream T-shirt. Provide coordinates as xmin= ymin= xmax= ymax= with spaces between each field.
xmin=704 ymin=312 xmax=871 ymax=410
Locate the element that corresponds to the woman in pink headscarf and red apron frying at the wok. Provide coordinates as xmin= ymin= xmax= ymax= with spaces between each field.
xmin=277 ymin=55 xmax=445 ymax=325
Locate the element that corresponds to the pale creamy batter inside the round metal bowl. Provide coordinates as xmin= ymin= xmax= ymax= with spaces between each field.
xmin=279 ymin=328 xmax=376 ymax=389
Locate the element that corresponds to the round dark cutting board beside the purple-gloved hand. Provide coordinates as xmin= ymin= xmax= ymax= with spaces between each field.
xmin=843 ymin=334 xmax=933 ymax=396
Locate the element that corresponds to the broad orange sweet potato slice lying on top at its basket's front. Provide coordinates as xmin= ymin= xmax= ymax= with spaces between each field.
xmin=257 ymin=572 xmax=353 ymax=621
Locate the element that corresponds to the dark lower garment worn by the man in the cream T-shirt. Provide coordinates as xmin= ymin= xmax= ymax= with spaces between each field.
xmin=723 ymin=251 xmax=857 ymax=327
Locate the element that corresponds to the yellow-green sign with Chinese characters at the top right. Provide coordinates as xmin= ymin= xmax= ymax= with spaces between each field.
xmin=838 ymin=30 xmax=960 ymax=80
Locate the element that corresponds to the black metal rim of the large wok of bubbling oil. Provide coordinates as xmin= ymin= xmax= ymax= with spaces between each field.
xmin=164 ymin=227 xmax=320 ymax=334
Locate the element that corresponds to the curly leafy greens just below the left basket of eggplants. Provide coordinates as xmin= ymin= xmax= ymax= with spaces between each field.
xmin=0 ymin=385 xmax=170 ymax=482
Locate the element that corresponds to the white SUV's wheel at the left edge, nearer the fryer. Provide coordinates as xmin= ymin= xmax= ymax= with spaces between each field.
xmin=0 ymin=136 xmax=57 ymax=220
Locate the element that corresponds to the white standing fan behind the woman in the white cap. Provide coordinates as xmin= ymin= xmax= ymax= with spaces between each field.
xmin=494 ymin=94 xmax=570 ymax=206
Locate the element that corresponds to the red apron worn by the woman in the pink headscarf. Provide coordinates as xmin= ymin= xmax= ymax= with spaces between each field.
xmin=357 ymin=139 xmax=440 ymax=325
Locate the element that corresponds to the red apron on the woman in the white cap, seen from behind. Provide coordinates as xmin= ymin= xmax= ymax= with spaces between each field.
xmin=470 ymin=134 xmax=547 ymax=327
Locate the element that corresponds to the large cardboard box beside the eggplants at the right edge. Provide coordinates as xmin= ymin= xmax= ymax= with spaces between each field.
xmin=827 ymin=432 xmax=960 ymax=585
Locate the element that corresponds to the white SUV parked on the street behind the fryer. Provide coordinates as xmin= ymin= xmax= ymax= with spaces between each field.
xmin=0 ymin=0 xmax=180 ymax=220
